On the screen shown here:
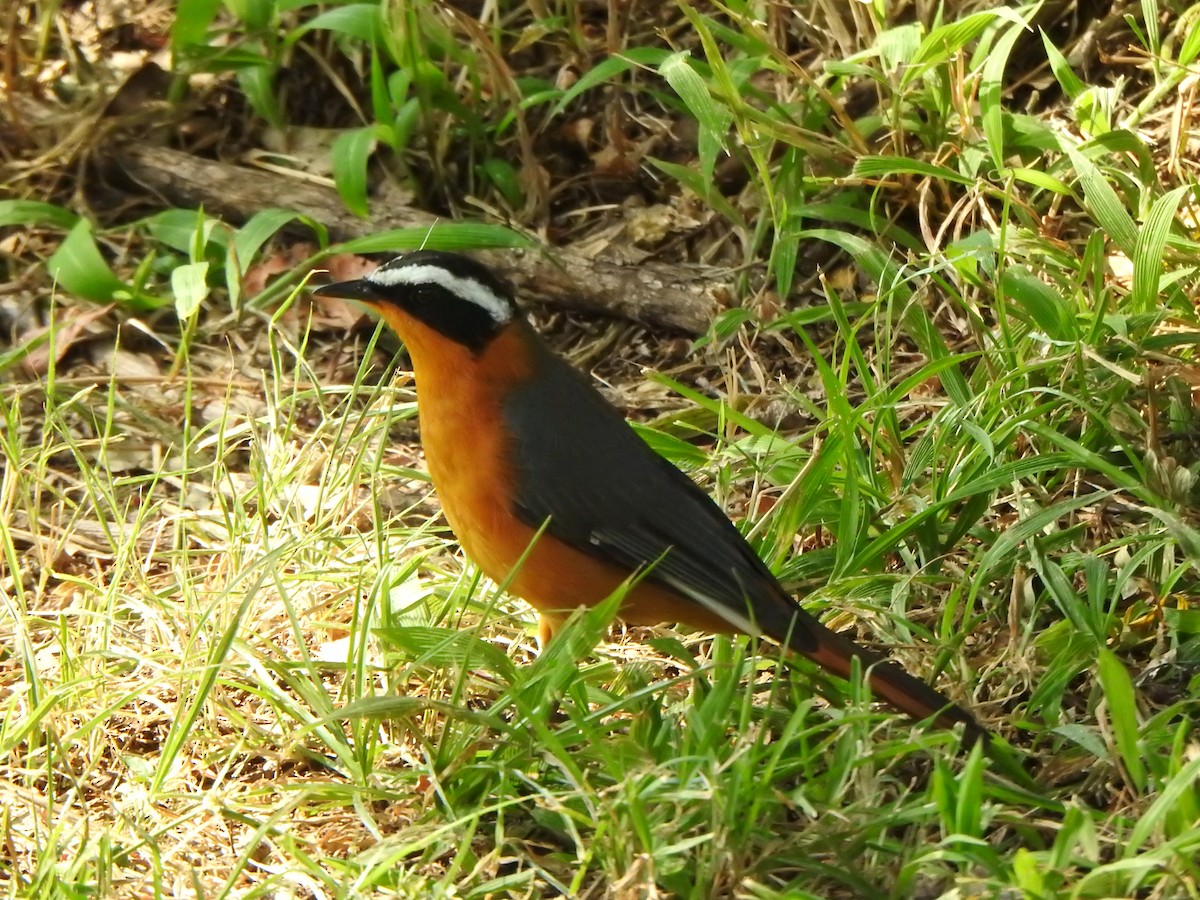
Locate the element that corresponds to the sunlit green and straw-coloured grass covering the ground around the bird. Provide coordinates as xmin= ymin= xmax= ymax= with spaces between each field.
xmin=0 ymin=0 xmax=1200 ymax=898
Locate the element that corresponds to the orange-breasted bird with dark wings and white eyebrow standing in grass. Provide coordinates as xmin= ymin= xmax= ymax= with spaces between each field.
xmin=314 ymin=250 xmax=990 ymax=746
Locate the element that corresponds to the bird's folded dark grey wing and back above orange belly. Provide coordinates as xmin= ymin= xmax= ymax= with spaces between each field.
xmin=504 ymin=333 xmax=823 ymax=652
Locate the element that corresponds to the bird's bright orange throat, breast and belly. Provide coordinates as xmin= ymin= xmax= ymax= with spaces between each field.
xmin=380 ymin=307 xmax=730 ymax=631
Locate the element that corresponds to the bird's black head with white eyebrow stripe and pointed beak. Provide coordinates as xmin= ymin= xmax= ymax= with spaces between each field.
xmin=314 ymin=250 xmax=517 ymax=353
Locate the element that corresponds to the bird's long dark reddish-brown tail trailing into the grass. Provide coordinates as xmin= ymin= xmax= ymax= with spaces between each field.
xmin=791 ymin=619 xmax=991 ymax=748
